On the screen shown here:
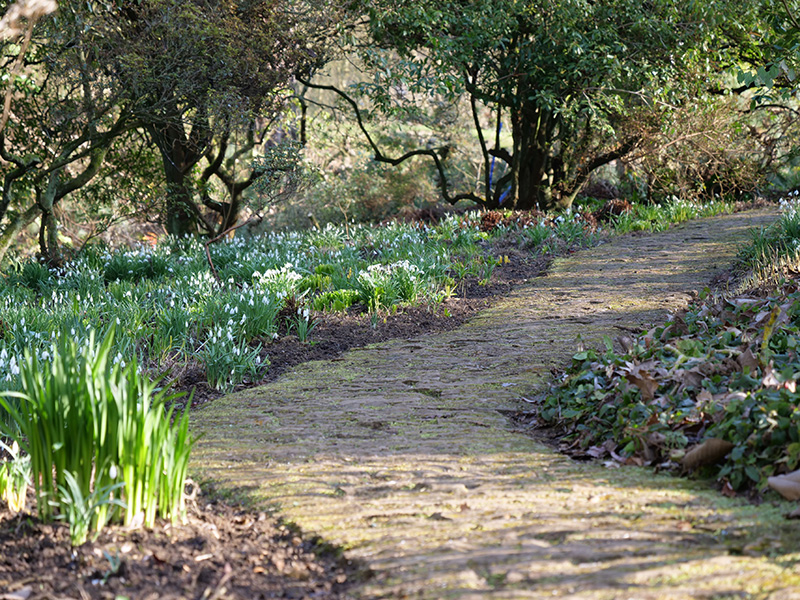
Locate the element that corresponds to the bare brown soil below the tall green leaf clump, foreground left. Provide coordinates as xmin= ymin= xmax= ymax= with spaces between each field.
xmin=0 ymin=496 xmax=356 ymax=600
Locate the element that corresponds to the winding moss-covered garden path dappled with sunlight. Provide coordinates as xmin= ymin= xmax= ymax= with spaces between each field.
xmin=192 ymin=211 xmax=800 ymax=600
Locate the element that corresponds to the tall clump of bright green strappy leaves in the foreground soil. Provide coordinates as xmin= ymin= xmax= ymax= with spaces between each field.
xmin=0 ymin=327 xmax=193 ymax=544
